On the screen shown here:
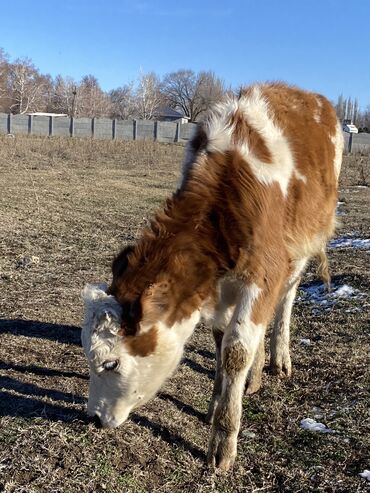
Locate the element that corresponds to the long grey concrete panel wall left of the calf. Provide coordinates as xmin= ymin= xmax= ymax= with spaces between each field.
xmin=0 ymin=113 xmax=196 ymax=142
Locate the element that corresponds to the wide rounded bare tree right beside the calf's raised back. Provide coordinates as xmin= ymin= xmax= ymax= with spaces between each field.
xmin=162 ymin=70 xmax=226 ymax=122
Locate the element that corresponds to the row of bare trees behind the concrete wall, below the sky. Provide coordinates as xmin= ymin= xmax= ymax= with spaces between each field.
xmin=0 ymin=48 xmax=370 ymax=132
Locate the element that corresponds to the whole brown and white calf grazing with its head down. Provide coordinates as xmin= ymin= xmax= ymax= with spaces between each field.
xmin=82 ymin=84 xmax=343 ymax=469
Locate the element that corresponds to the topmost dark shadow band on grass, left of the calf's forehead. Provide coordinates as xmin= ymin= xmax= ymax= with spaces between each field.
xmin=0 ymin=319 xmax=81 ymax=346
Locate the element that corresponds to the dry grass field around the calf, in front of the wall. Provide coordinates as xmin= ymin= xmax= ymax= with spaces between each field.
xmin=0 ymin=137 xmax=370 ymax=493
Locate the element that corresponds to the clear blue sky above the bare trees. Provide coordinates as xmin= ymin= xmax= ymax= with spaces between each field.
xmin=0 ymin=0 xmax=370 ymax=108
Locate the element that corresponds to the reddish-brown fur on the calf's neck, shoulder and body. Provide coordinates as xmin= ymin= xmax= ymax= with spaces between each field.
xmin=110 ymin=84 xmax=337 ymax=338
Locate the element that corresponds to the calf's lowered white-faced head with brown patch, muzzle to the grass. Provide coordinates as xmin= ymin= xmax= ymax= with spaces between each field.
xmin=81 ymin=285 xmax=199 ymax=428
